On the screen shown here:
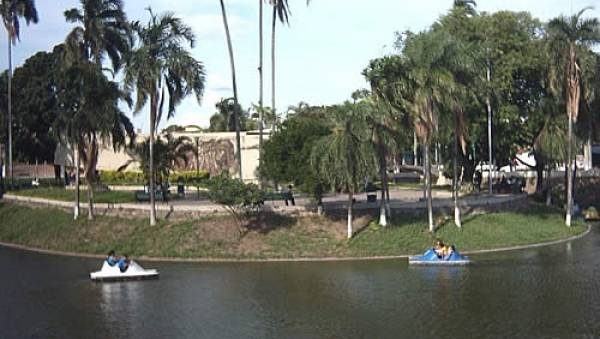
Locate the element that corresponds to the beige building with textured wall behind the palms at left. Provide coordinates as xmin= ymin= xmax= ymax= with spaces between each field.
xmin=54 ymin=126 xmax=269 ymax=182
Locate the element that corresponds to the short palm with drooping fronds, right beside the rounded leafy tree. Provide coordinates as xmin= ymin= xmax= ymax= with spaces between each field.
xmin=311 ymin=103 xmax=376 ymax=239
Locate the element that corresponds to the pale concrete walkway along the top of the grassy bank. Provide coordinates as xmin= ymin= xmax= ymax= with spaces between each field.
xmin=4 ymin=189 xmax=527 ymax=214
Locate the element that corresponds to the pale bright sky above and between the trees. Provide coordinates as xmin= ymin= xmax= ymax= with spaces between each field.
xmin=0 ymin=0 xmax=600 ymax=131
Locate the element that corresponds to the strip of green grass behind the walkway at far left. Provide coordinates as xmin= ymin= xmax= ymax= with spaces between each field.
xmin=9 ymin=187 xmax=135 ymax=204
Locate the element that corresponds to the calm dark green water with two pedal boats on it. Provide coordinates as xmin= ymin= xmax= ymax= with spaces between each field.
xmin=0 ymin=229 xmax=600 ymax=338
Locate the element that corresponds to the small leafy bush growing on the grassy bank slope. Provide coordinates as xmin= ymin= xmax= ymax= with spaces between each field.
xmin=208 ymin=173 xmax=265 ymax=238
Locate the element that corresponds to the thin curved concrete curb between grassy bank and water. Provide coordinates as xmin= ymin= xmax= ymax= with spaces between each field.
xmin=0 ymin=224 xmax=592 ymax=264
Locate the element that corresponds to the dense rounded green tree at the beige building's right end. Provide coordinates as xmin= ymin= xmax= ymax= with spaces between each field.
xmin=259 ymin=107 xmax=331 ymax=214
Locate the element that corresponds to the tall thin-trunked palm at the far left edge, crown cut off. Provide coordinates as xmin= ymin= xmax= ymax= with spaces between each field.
xmin=0 ymin=0 xmax=38 ymax=181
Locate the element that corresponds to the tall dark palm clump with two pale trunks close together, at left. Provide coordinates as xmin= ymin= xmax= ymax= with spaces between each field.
xmin=63 ymin=0 xmax=131 ymax=220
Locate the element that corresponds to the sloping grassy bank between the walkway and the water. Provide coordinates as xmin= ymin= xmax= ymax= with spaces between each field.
xmin=0 ymin=203 xmax=585 ymax=258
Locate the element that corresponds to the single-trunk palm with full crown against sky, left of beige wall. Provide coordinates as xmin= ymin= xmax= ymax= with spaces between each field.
xmin=125 ymin=8 xmax=204 ymax=225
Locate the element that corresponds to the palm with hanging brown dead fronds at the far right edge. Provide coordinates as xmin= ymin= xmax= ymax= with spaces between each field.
xmin=548 ymin=7 xmax=600 ymax=227
